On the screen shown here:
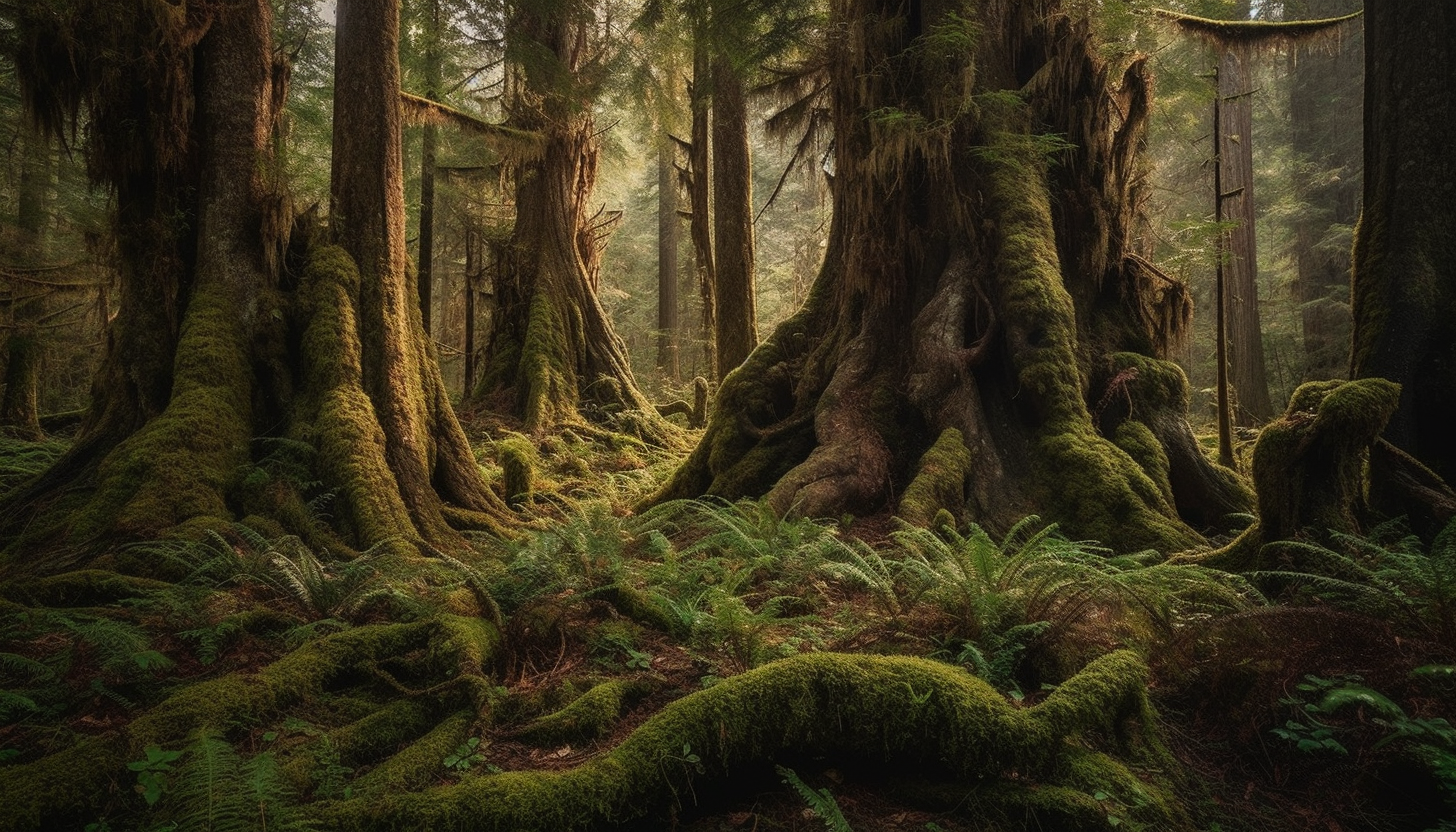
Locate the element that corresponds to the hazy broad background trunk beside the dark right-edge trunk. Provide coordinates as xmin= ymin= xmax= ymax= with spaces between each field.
xmin=1284 ymin=0 xmax=1364 ymax=380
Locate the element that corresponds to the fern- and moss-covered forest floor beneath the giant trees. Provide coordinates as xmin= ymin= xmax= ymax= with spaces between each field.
xmin=0 ymin=423 xmax=1456 ymax=832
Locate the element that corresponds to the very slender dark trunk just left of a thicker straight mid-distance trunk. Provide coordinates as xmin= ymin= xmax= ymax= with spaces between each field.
xmin=687 ymin=38 xmax=719 ymax=379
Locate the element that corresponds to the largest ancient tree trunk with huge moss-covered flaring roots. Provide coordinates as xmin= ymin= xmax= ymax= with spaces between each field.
xmin=658 ymin=0 xmax=1232 ymax=549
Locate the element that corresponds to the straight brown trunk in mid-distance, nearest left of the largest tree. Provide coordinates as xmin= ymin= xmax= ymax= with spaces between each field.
xmin=712 ymin=55 xmax=759 ymax=380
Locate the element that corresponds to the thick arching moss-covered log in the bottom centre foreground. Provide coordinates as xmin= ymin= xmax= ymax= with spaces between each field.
xmin=320 ymin=653 xmax=1164 ymax=831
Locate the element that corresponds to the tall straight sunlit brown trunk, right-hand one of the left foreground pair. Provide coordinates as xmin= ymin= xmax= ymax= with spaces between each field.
xmin=331 ymin=0 xmax=498 ymax=541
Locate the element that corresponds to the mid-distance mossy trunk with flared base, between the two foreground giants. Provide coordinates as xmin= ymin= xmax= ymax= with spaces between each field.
xmin=478 ymin=3 xmax=662 ymax=434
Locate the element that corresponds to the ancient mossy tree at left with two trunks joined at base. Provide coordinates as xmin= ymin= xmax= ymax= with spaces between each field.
xmin=0 ymin=0 xmax=499 ymax=567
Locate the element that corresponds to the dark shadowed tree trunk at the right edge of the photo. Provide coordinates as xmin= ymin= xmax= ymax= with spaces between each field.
xmin=1351 ymin=0 xmax=1456 ymax=479
